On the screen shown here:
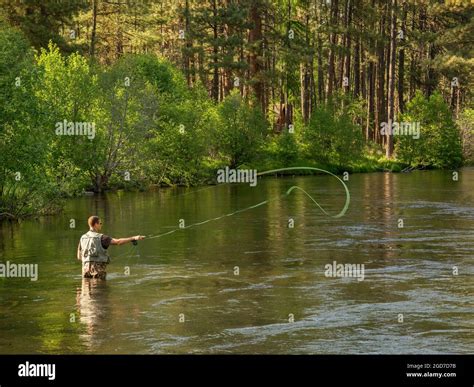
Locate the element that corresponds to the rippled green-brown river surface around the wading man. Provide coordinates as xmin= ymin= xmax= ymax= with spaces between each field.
xmin=0 ymin=168 xmax=474 ymax=354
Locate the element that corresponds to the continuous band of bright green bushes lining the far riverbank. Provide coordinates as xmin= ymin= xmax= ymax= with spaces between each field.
xmin=0 ymin=39 xmax=471 ymax=223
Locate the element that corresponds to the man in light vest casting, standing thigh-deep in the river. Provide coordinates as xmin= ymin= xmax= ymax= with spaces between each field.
xmin=77 ymin=216 xmax=145 ymax=279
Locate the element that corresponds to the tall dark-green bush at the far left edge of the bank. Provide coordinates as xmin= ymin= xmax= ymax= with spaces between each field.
xmin=0 ymin=24 xmax=58 ymax=218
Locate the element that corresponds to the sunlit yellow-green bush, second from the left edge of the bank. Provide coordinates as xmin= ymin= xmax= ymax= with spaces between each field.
xmin=34 ymin=43 xmax=98 ymax=194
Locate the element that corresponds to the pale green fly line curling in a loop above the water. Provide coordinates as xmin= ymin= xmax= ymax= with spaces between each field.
xmin=146 ymin=167 xmax=351 ymax=240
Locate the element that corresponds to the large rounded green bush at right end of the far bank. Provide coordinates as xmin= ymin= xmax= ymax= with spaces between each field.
xmin=395 ymin=92 xmax=462 ymax=168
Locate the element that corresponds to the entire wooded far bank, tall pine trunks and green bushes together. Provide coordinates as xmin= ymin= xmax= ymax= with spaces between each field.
xmin=0 ymin=0 xmax=474 ymax=219
